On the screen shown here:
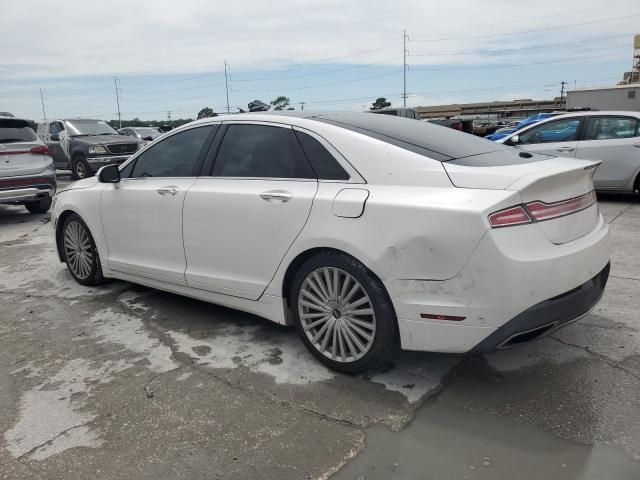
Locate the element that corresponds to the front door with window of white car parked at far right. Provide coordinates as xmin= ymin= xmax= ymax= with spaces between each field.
xmin=505 ymin=117 xmax=584 ymax=157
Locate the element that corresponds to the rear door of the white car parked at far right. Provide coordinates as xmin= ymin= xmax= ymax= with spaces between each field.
xmin=576 ymin=115 xmax=640 ymax=188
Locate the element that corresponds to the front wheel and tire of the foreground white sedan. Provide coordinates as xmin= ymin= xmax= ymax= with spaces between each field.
xmin=60 ymin=214 xmax=104 ymax=286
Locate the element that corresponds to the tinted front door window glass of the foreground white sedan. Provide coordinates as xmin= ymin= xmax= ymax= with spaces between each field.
xmin=131 ymin=125 xmax=214 ymax=178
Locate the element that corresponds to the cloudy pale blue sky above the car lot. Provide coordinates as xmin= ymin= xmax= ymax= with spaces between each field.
xmin=0 ymin=0 xmax=640 ymax=119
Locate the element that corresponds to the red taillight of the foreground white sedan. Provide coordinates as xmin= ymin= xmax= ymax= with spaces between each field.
xmin=489 ymin=190 xmax=597 ymax=228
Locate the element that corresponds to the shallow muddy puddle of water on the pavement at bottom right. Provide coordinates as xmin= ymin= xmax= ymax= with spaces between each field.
xmin=332 ymin=401 xmax=640 ymax=480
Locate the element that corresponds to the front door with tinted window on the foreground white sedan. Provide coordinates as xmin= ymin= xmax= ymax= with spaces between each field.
xmin=101 ymin=125 xmax=217 ymax=285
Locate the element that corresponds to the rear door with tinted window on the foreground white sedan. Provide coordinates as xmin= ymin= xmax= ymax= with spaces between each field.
xmin=183 ymin=122 xmax=318 ymax=300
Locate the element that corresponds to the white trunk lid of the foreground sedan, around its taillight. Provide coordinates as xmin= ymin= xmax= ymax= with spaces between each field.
xmin=443 ymin=156 xmax=600 ymax=244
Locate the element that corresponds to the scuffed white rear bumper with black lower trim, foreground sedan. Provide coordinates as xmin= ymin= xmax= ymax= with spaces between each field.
xmin=388 ymin=217 xmax=609 ymax=353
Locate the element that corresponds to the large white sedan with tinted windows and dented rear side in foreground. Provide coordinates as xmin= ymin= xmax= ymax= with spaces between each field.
xmin=52 ymin=112 xmax=609 ymax=373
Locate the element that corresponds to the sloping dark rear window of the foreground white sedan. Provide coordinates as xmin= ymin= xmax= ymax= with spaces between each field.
xmin=312 ymin=112 xmax=511 ymax=162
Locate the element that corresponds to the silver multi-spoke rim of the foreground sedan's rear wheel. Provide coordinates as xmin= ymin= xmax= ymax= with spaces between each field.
xmin=298 ymin=267 xmax=376 ymax=362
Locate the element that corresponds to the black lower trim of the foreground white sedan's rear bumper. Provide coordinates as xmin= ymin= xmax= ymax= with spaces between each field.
xmin=470 ymin=264 xmax=611 ymax=354
